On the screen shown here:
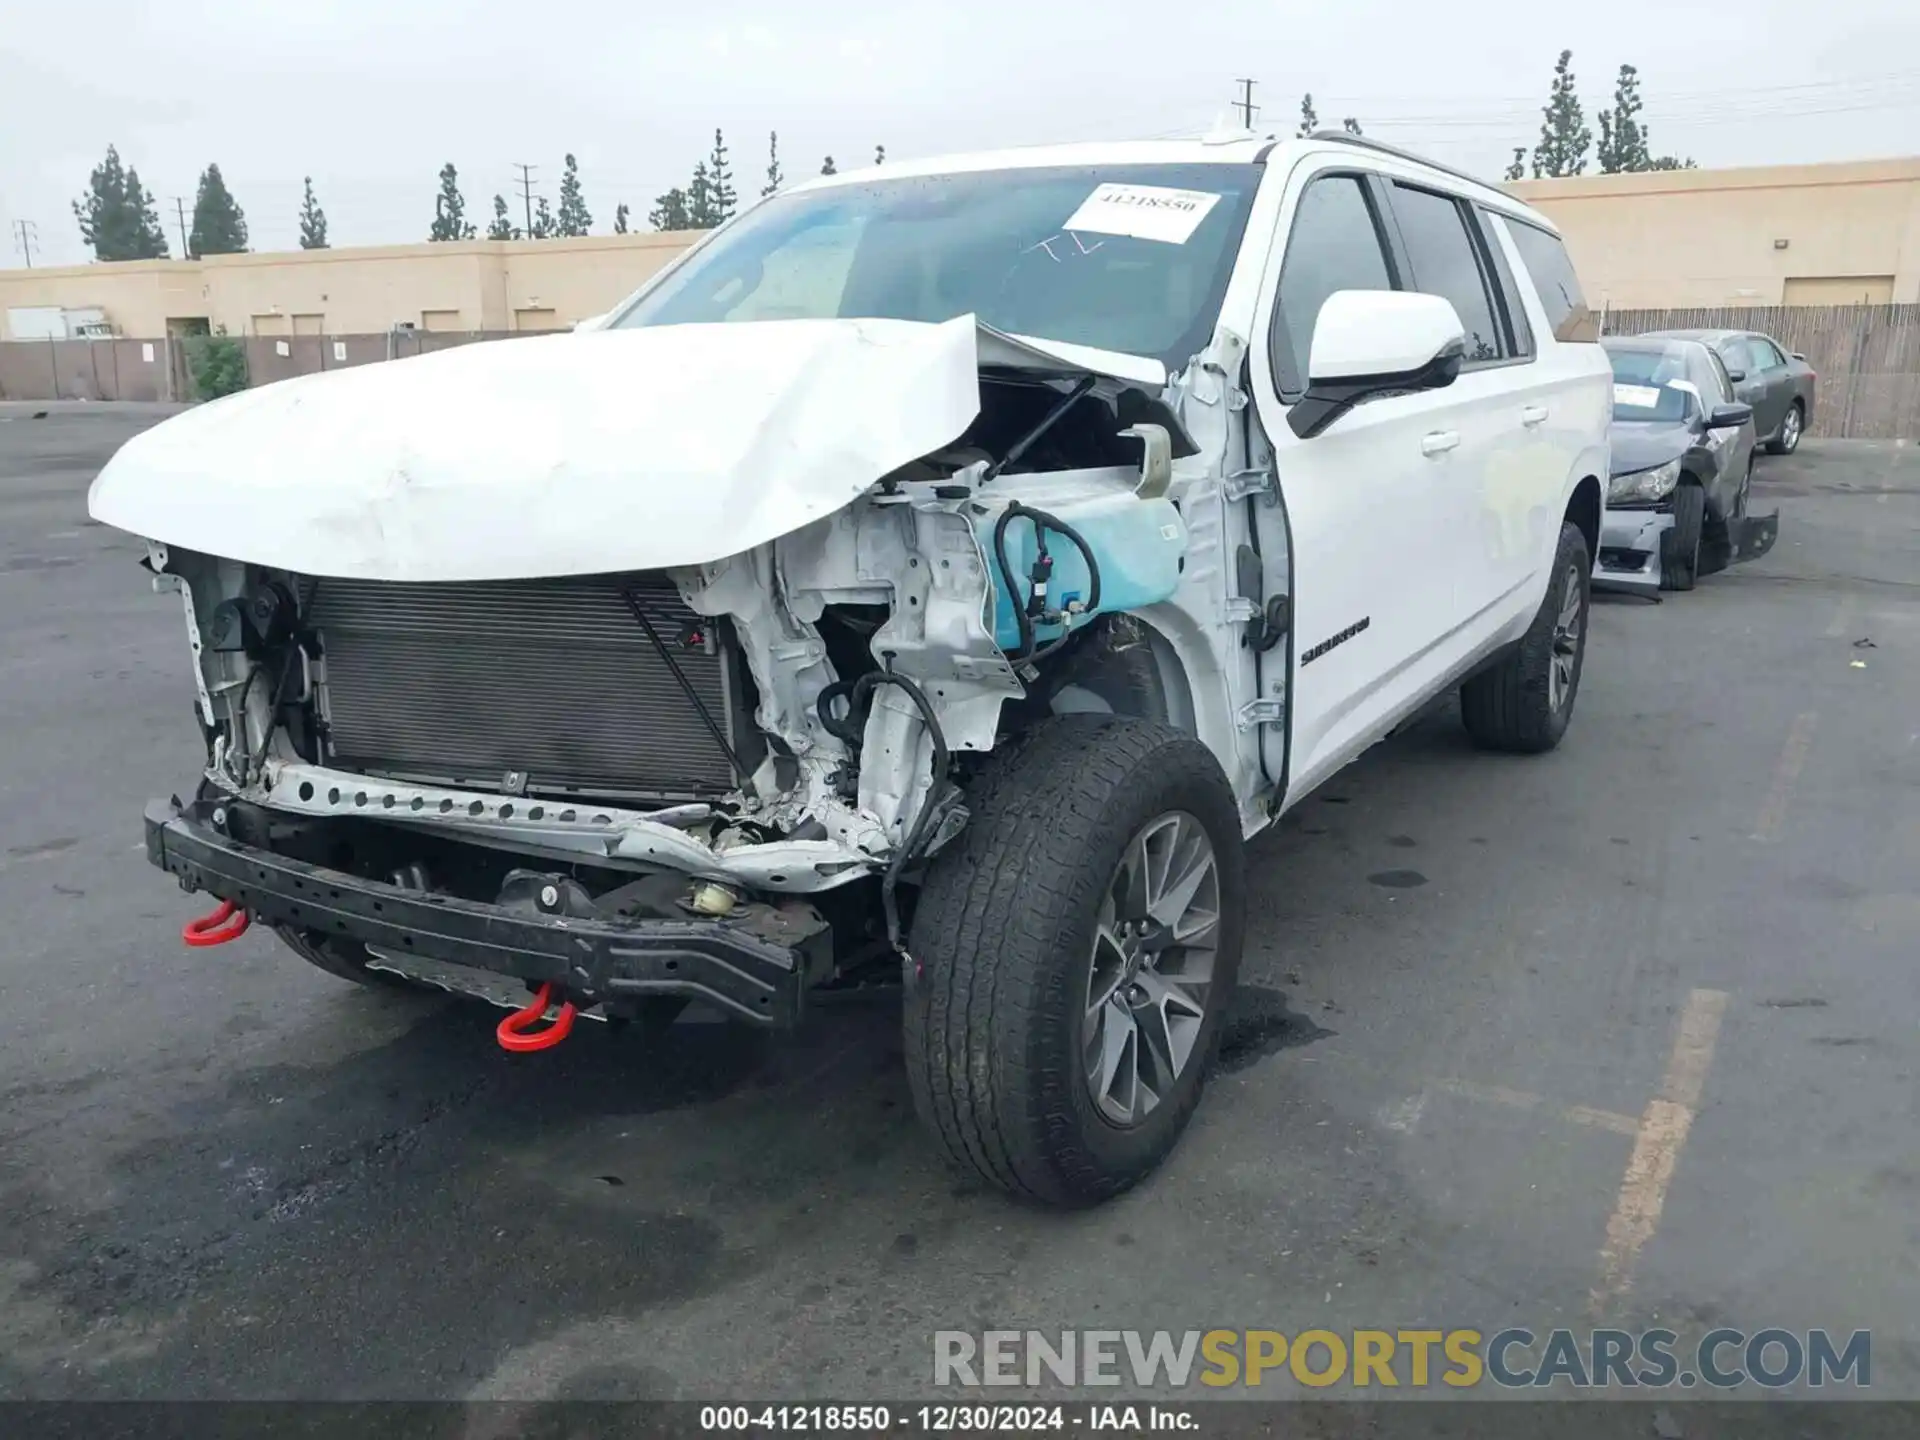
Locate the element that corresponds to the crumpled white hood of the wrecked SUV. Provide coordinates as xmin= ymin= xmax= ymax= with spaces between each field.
xmin=86 ymin=317 xmax=979 ymax=580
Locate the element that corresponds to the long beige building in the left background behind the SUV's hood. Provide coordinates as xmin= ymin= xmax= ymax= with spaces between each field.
xmin=0 ymin=232 xmax=699 ymax=338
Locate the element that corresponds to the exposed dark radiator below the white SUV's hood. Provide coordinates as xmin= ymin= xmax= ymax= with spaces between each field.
xmin=307 ymin=572 xmax=737 ymax=799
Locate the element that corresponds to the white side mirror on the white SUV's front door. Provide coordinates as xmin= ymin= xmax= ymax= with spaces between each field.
xmin=1286 ymin=290 xmax=1467 ymax=440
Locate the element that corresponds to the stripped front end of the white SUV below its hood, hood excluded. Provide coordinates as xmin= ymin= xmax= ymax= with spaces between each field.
xmin=120 ymin=326 xmax=1192 ymax=1025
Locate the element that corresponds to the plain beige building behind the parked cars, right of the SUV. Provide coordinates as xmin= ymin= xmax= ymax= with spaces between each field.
xmin=1507 ymin=157 xmax=1920 ymax=309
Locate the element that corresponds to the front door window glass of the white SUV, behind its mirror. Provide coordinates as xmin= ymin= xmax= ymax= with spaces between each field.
xmin=1271 ymin=175 xmax=1396 ymax=396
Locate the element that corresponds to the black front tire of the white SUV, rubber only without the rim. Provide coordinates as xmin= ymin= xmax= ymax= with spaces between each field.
xmin=904 ymin=714 xmax=1246 ymax=1206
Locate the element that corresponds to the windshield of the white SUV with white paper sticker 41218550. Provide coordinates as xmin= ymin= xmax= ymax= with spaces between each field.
xmin=611 ymin=165 xmax=1261 ymax=371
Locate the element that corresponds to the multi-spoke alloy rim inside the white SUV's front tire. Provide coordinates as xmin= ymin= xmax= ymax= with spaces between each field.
xmin=1081 ymin=810 xmax=1219 ymax=1129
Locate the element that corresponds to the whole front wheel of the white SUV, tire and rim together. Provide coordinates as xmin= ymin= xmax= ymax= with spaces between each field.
xmin=904 ymin=714 xmax=1246 ymax=1206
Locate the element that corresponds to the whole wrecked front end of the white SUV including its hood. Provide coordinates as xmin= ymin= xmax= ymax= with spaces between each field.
xmin=90 ymin=321 xmax=1192 ymax=1025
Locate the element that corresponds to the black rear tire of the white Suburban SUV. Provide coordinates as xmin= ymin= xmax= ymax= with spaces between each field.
xmin=1459 ymin=522 xmax=1594 ymax=755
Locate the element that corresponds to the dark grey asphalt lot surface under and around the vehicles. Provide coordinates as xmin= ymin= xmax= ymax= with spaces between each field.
xmin=0 ymin=409 xmax=1920 ymax=1400
